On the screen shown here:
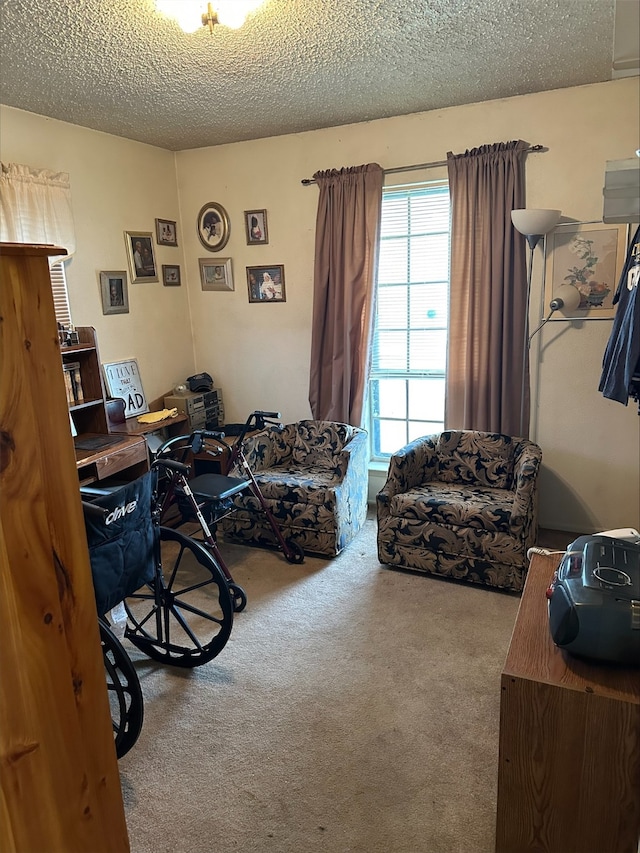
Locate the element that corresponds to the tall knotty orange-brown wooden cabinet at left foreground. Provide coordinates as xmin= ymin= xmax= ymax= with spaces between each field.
xmin=0 ymin=243 xmax=129 ymax=853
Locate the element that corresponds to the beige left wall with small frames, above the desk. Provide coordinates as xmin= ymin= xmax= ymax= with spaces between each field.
xmin=0 ymin=107 xmax=194 ymax=400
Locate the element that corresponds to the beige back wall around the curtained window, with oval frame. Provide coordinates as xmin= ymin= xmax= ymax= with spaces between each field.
xmin=177 ymin=77 xmax=640 ymax=531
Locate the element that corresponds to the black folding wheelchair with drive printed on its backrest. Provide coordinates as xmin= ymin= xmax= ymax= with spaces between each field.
xmin=81 ymin=460 xmax=234 ymax=758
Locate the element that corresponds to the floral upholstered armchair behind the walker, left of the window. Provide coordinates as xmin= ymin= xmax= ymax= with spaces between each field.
xmin=220 ymin=420 xmax=369 ymax=557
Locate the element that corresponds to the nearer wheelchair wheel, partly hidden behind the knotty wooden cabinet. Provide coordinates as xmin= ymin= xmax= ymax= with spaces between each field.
xmin=98 ymin=619 xmax=144 ymax=758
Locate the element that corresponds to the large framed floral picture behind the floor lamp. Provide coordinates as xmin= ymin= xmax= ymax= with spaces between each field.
xmin=544 ymin=222 xmax=629 ymax=320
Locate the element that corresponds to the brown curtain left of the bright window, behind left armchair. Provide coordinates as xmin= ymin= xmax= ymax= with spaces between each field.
xmin=309 ymin=163 xmax=384 ymax=426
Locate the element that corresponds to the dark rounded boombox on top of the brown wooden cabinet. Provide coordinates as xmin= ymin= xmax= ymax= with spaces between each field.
xmin=547 ymin=531 xmax=640 ymax=666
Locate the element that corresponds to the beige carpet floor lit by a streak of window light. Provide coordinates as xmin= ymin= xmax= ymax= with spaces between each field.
xmin=120 ymin=518 xmax=519 ymax=853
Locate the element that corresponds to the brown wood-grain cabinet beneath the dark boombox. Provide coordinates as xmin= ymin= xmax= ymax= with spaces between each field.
xmin=496 ymin=554 xmax=640 ymax=853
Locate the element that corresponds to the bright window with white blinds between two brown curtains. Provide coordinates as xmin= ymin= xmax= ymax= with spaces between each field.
xmin=369 ymin=181 xmax=449 ymax=461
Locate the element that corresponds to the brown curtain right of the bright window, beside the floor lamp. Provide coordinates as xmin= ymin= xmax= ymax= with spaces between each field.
xmin=445 ymin=141 xmax=529 ymax=435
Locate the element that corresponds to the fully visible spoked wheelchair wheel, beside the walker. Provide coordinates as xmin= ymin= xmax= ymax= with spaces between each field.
xmin=125 ymin=527 xmax=233 ymax=667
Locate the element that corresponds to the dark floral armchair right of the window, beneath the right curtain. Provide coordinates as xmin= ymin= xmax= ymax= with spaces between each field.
xmin=377 ymin=430 xmax=542 ymax=592
